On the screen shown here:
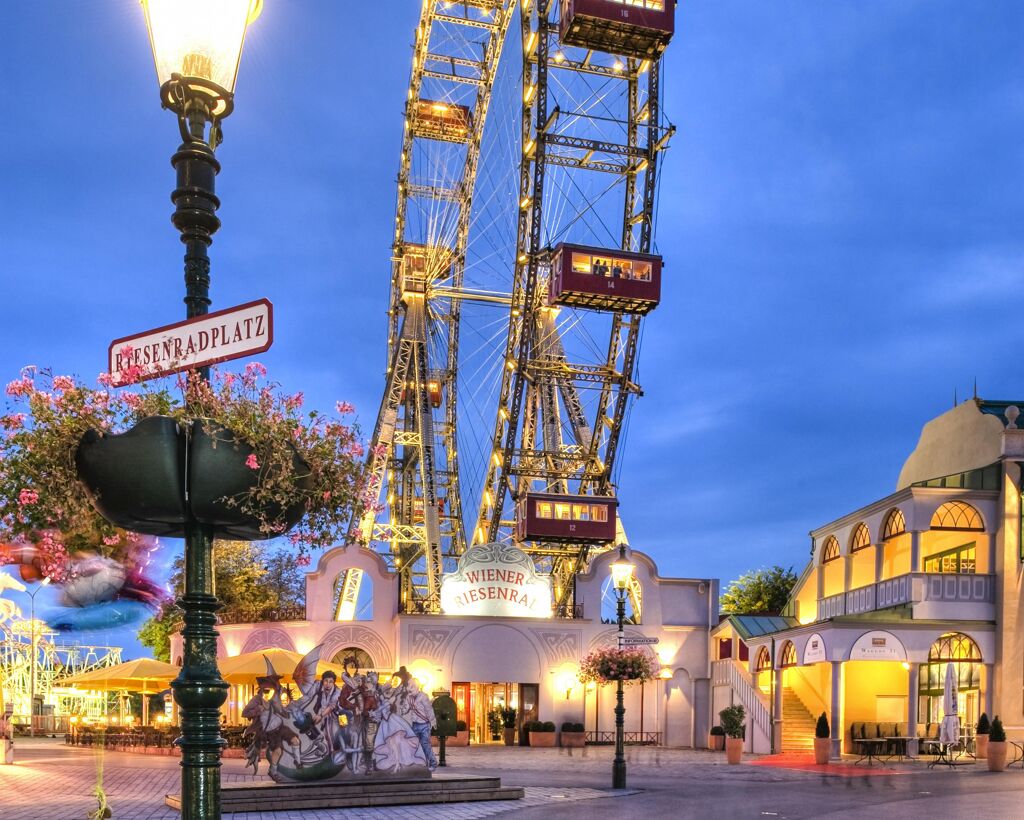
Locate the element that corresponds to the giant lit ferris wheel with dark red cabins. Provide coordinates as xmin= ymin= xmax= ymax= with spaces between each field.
xmin=356 ymin=0 xmax=675 ymax=615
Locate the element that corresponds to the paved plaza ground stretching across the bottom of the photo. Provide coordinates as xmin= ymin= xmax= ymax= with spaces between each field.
xmin=0 ymin=739 xmax=1024 ymax=820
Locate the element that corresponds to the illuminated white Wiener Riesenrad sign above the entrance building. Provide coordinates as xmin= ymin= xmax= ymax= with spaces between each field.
xmin=441 ymin=544 xmax=551 ymax=618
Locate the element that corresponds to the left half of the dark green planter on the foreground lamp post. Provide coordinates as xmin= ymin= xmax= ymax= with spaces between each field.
xmin=75 ymin=416 xmax=188 ymax=537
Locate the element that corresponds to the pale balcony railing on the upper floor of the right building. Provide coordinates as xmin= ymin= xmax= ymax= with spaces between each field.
xmin=817 ymin=572 xmax=995 ymax=620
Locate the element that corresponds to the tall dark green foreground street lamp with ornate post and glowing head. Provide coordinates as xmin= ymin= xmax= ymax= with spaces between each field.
xmin=141 ymin=0 xmax=263 ymax=820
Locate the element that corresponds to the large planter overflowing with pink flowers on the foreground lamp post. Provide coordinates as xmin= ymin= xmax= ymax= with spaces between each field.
xmin=0 ymin=366 xmax=364 ymax=563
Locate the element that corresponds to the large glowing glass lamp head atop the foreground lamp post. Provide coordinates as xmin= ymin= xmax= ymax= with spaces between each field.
xmin=140 ymin=0 xmax=263 ymax=117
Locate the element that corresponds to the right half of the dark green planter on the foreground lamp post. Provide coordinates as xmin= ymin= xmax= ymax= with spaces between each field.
xmin=188 ymin=419 xmax=312 ymax=541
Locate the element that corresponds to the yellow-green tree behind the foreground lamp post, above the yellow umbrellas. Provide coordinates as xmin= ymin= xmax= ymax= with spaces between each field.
xmin=138 ymin=541 xmax=306 ymax=662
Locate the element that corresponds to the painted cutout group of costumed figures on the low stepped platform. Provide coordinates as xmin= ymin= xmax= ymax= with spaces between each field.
xmin=242 ymin=646 xmax=436 ymax=782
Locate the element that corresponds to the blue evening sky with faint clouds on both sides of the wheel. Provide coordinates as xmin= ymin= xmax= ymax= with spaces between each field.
xmin=0 ymin=0 xmax=1024 ymax=651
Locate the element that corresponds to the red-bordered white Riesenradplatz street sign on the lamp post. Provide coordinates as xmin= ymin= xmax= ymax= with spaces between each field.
xmin=108 ymin=299 xmax=273 ymax=387
